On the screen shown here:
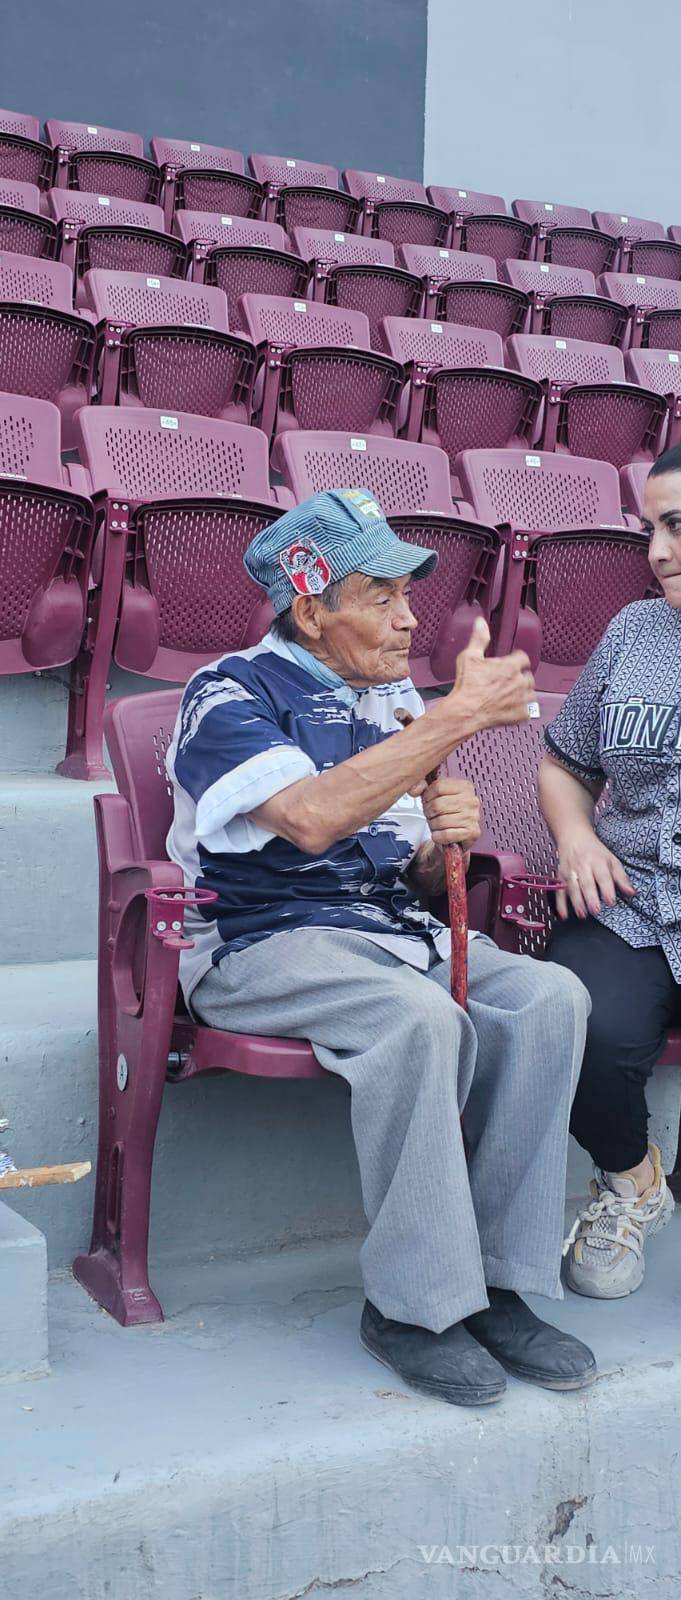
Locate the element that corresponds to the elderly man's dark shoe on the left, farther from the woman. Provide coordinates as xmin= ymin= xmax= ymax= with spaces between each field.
xmin=360 ymin=1301 xmax=507 ymax=1405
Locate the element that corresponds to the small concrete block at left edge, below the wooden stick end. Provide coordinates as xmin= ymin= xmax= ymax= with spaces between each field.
xmin=0 ymin=1203 xmax=48 ymax=1384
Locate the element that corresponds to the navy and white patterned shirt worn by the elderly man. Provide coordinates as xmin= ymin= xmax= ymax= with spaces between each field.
xmin=168 ymin=634 xmax=451 ymax=1002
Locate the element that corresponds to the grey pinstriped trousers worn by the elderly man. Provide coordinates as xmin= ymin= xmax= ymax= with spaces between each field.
xmin=192 ymin=928 xmax=590 ymax=1333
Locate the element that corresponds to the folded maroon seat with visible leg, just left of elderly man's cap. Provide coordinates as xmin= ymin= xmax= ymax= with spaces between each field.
xmin=59 ymin=406 xmax=283 ymax=778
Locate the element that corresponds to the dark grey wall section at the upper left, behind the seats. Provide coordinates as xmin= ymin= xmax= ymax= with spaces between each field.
xmin=0 ymin=0 xmax=427 ymax=176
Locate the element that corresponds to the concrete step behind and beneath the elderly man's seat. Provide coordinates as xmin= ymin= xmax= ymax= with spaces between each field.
xmin=0 ymin=962 xmax=363 ymax=1266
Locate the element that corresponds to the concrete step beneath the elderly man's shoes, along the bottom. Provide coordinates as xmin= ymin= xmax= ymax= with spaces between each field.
xmin=0 ymin=1216 xmax=681 ymax=1600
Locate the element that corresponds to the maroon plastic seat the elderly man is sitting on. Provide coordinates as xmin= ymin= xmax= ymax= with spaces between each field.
xmin=74 ymin=688 xmax=326 ymax=1326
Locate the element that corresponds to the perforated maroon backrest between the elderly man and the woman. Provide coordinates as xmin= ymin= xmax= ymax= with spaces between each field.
xmin=448 ymin=693 xmax=563 ymax=877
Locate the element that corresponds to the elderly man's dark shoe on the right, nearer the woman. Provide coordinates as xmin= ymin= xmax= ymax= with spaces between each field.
xmin=465 ymin=1288 xmax=596 ymax=1389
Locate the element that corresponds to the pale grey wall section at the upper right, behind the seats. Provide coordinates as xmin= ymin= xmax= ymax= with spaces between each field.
xmin=425 ymin=0 xmax=681 ymax=224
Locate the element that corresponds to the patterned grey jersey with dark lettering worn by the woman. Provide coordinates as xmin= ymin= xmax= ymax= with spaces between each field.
xmin=545 ymin=600 xmax=681 ymax=982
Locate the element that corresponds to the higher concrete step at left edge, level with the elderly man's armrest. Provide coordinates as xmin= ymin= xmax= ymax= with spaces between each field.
xmin=0 ymin=773 xmax=114 ymax=963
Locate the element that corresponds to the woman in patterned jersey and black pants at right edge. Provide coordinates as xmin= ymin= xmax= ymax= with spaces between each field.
xmin=539 ymin=445 xmax=681 ymax=1299
